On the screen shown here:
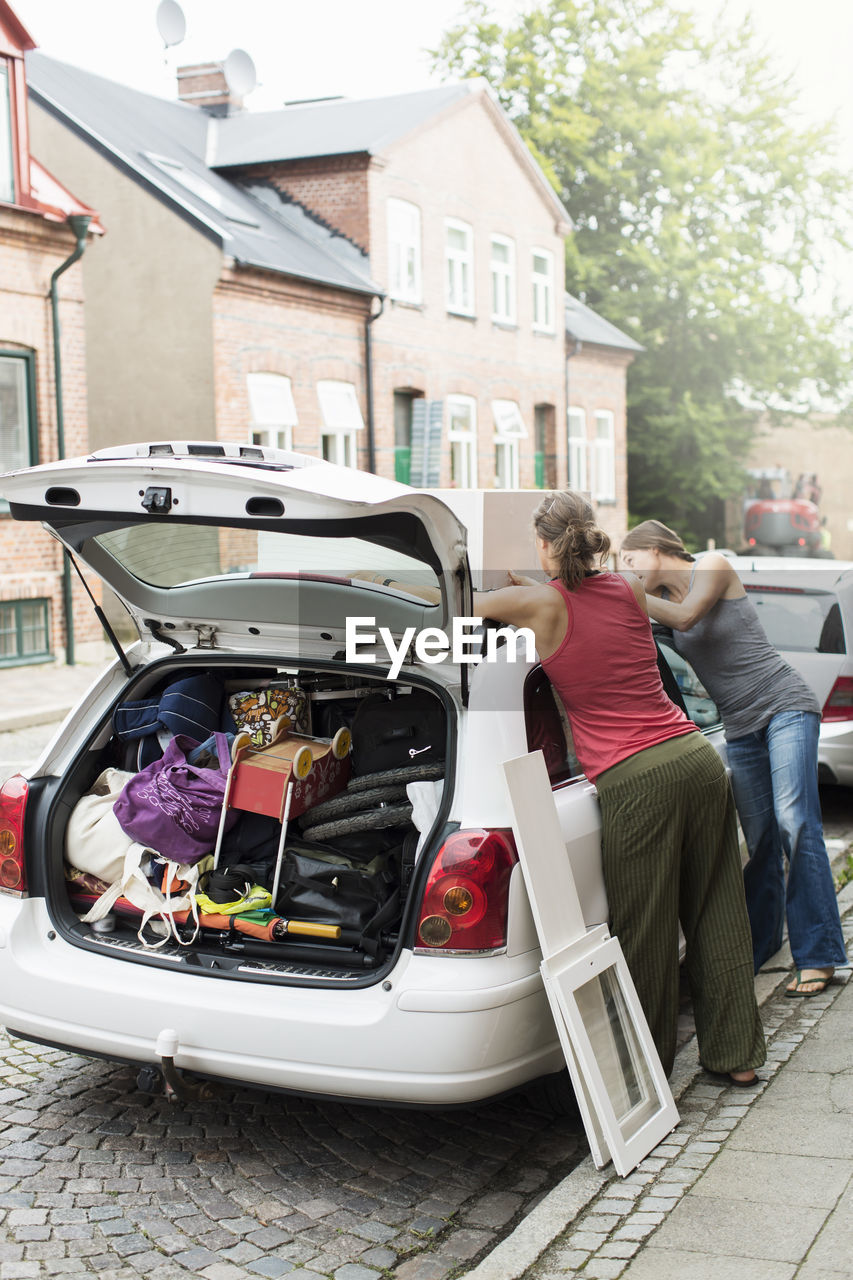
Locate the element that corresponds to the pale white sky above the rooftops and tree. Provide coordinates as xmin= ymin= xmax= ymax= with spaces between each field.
xmin=10 ymin=0 xmax=853 ymax=168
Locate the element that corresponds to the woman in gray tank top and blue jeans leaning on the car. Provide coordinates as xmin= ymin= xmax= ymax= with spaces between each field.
xmin=621 ymin=520 xmax=847 ymax=996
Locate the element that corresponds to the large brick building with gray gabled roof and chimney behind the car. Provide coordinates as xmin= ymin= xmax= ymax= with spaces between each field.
xmin=28 ymin=54 xmax=640 ymax=593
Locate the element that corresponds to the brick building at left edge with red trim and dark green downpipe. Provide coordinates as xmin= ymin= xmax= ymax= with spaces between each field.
xmin=0 ymin=0 xmax=101 ymax=666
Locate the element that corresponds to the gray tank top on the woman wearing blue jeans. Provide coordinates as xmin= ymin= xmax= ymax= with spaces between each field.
xmin=674 ymin=580 xmax=821 ymax=740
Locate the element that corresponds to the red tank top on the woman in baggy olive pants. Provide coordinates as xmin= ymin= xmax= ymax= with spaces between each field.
xmin=542 ymin=572 xmax=695 ymax=782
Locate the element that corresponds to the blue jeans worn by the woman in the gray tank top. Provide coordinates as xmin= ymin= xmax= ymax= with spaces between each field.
xmin=726 ymin=712 xmax=847 ymax=973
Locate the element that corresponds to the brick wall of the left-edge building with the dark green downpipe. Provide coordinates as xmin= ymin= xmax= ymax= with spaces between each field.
xmin=0 ymin=209 xmax=101 ymax=654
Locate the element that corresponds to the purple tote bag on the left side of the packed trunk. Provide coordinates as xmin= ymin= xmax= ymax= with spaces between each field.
xmin=113 ymin=733 xmax=240 ymax=863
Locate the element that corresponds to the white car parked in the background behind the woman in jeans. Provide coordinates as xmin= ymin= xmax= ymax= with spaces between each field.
xmin=731 ymin=556 xmax=853 ymax=786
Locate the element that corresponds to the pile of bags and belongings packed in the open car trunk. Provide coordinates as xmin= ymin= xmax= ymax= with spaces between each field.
xmin=65 ymin=672 xmax=446 ymax=968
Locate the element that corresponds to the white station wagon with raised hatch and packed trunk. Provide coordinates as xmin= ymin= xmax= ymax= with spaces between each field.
xmin=0 ymin=442 xmax=719 ymax=1106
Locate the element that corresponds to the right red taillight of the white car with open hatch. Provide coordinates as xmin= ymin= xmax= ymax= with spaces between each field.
xmin=415 ymin=829 xmax=519 ymax=952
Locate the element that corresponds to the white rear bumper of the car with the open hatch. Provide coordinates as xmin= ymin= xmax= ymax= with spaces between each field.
xmin=0 ymin=896 xmax=564 ymax=1106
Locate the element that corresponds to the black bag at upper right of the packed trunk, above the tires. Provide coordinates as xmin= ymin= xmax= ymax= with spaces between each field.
xmin=352 ymin=689 xmax=447 ymax=774
